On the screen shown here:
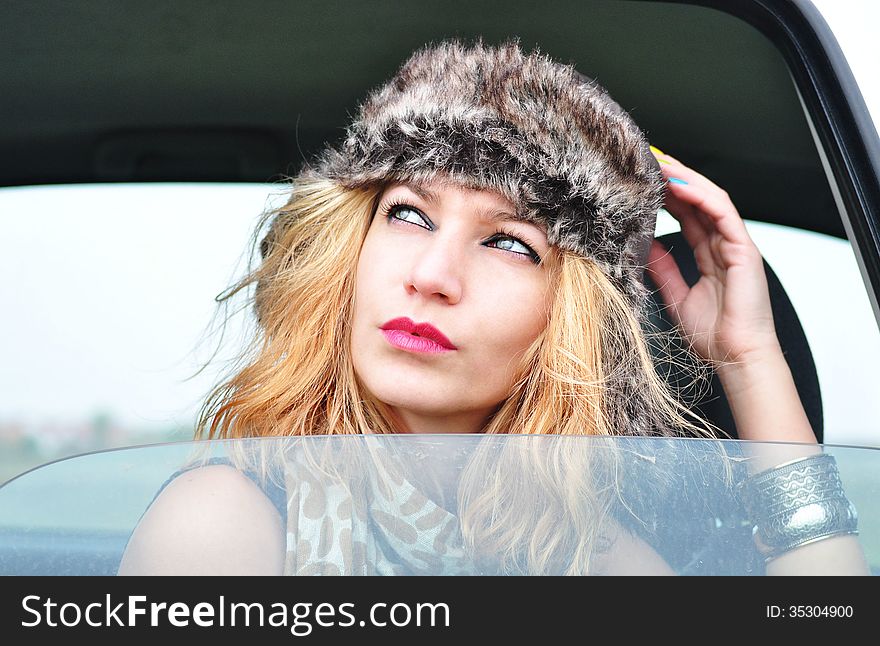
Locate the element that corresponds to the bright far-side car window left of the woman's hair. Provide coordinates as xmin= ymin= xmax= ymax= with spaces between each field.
xmin=0 ymin=184 xmax=273 ymax=480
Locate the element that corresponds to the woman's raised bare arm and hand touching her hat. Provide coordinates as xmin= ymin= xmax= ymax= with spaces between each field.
xmin=648 ymin=150 xmax=868 ymax=574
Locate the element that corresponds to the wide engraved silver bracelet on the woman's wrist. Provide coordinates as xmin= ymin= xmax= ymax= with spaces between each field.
xmin=741 ymin=454 xmax=858 ymax=561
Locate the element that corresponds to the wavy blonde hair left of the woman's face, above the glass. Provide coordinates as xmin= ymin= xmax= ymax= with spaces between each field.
xmin=196 ymin=179 xmax=394 ymax=438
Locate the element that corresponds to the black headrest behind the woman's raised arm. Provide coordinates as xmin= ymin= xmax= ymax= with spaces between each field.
xmin=645 ymin=233 xmax=823 ymax=442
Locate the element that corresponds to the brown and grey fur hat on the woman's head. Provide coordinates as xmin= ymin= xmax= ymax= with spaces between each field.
xmin=305 ymin=41 xmax=664 ymax=309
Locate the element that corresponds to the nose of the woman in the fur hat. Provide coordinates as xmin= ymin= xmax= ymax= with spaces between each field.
xmin=406 ymin=235 xmax=465 ymax=305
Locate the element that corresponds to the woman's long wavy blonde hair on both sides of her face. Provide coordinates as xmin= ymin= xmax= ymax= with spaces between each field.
xmin=196 ymin=176 xmax=713 ymax=574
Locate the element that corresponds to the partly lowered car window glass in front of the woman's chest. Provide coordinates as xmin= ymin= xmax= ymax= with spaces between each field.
xmin=0 ymin=435 xmax=880 ymax=575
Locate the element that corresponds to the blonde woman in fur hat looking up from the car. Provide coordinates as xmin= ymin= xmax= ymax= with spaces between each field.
xmin=120 ymin=42 xmax=864 ymax=574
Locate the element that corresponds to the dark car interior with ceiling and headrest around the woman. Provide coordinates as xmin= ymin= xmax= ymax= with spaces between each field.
xmin=0 ymin=0 xmax=880 ymax=567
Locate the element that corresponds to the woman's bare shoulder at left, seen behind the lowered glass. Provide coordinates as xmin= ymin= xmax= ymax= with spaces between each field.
xmin=119 ymin=465 xmax=285 ymax=574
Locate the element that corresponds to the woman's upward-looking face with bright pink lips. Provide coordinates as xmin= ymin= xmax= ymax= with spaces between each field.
xmin=351 ymin=182 xmax=549 ymax=432
